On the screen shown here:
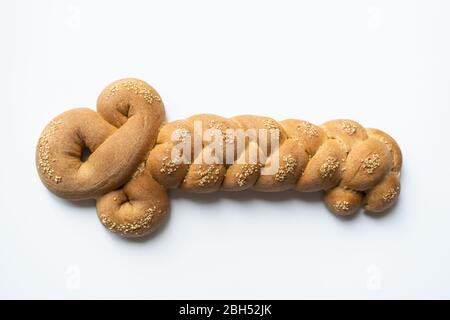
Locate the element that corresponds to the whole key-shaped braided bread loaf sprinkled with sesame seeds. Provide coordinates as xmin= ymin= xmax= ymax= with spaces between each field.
xmin=36 ymin=79 xmax=402 ymax=237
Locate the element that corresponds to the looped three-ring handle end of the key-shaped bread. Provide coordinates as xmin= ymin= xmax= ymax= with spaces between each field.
xmin=36 ymin=79 xmax=168 ymax=236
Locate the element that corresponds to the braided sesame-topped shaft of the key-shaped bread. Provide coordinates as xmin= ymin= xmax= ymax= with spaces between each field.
xmin=149 ymin=114 xmax=401 ymax=215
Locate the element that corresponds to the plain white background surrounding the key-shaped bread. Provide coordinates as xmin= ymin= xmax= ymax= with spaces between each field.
xmin=0 ymin=0 xmax=450 ymax=299
